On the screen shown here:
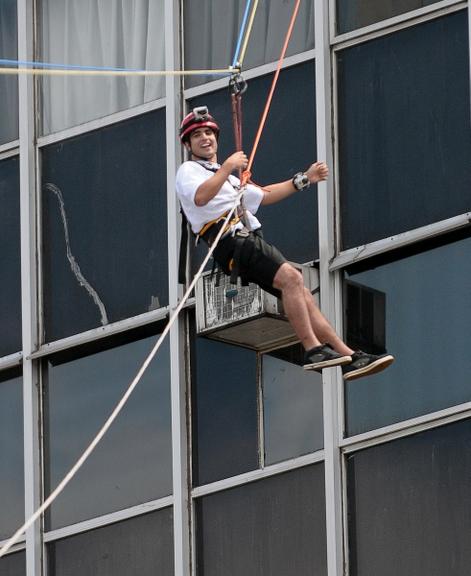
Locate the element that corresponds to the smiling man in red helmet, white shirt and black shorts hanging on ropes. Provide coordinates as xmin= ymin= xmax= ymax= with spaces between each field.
xmin=176 ymin=106 xmax=394 ymax=380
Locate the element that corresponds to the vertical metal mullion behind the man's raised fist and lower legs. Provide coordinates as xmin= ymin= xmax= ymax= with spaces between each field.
xmin=314 ymin=2 xmax=344 ymax=576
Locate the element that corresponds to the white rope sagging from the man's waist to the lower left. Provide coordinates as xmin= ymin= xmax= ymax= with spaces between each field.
xmin=0 ymin=187 xmax=245 ymax=558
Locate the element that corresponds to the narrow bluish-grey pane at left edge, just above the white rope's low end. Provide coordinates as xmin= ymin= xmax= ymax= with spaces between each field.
xmin=0 ymin=369 xmax=24 ymax=540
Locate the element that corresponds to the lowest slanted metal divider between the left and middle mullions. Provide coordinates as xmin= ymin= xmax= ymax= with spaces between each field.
xmin=44 ymin=496 xmax=173 ymax=542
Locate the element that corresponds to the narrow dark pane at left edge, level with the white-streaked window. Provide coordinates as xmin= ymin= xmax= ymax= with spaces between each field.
xmin=0 ymin=156 xmax=22 ymax=356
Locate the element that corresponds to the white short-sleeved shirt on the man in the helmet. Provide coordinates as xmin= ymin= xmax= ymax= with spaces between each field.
xmin=176 ymin=161 xmax=264 ymax=234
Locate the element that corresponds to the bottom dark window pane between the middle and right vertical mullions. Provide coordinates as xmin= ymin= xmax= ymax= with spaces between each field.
xmin=196 ymin=464 xmax=327 ymax=576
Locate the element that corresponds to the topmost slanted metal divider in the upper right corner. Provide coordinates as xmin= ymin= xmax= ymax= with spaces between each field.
xmin=331 ymin=0 xmax=467 ymax=50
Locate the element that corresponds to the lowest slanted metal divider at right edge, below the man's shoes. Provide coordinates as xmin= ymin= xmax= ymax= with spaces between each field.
xmin=339 ymin=402 xmax=471 ymax=454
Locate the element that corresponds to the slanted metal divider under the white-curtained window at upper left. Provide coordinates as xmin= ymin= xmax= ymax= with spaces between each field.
xmin=38 ymin=98 xmax=166 ymax=147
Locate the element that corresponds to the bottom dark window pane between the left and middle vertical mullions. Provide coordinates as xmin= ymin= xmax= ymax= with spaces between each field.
xmin=48 ymin=508 xmax=174 ymax=576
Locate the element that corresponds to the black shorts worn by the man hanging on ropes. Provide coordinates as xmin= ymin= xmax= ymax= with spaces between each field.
xmin=213 ymin=230 xmax=287 ymax=298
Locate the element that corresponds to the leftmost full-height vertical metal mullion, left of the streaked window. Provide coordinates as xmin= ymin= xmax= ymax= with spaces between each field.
xmin=18 ymin=0 xmax=42 ymax=576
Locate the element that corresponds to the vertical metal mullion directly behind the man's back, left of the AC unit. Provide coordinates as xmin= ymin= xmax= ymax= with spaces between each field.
xmin=164 ymin=0 xmax=191 ymax=576
